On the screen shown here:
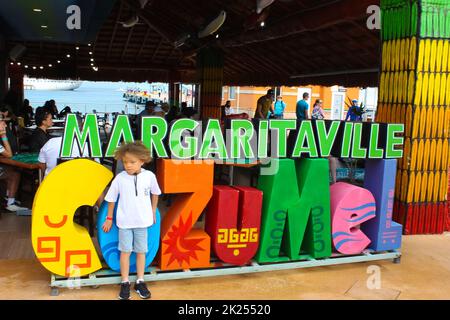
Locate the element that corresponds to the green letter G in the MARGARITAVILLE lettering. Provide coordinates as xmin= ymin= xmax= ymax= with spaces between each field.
xmin=170 ymin=119 xmax=198 ymax=159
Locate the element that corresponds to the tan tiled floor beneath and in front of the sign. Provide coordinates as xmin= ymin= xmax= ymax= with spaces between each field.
xmin=0 ymin=214 xmax=450 ymax=300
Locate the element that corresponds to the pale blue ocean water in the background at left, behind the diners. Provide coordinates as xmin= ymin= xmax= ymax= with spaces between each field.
xmin=24 ymin=81 xmax=164 ymax=114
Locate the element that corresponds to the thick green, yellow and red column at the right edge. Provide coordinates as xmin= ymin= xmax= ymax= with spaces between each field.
xmin=376 ymin=0 xmax=450 ymax=234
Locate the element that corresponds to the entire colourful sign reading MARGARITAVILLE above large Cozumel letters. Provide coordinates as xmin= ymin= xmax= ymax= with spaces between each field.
xmin=32 ymin=115 xmax=403 ymax=276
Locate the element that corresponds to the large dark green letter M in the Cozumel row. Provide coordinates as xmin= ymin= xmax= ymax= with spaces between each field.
xmin=255 ymin=159 xmax=331 ymax=263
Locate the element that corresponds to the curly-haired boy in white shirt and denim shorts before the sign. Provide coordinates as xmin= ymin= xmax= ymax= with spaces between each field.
xmin=103 ymin=142 xmax=161 ymax=300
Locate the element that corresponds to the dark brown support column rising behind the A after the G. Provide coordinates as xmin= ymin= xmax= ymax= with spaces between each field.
xmin=197 ymin=48 xmax=224 ymax=120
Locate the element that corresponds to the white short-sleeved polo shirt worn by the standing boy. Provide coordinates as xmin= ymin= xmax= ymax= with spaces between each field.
xmin=105 ymin=169 xmax=161 ymax=229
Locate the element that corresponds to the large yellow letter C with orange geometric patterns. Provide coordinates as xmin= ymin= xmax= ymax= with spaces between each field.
xmin=31 ymin=159 xmax=113 ymax=277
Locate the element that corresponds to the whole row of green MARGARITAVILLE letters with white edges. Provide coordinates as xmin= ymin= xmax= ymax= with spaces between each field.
xmin=61 ymin=114 xmax=404 ymax=159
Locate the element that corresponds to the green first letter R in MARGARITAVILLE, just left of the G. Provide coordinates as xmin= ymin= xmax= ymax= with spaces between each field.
xmin=141 ymin=117 xmax=167 ymax=158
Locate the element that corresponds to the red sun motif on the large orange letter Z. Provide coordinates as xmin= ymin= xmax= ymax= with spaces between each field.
xmin=162 ymin=212 xmax=204 ymax=267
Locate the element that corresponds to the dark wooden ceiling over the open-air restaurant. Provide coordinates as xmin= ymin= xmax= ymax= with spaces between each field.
xmin=5 ymin=0 xmax=380 ymax=86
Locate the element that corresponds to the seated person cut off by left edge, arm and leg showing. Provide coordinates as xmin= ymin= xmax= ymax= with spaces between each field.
xmin=0 ymin=121 xmax=28 ymax=212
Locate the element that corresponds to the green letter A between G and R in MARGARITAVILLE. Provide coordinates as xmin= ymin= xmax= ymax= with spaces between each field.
xmin=199 ymin=119 xmax=228 ymax=159
